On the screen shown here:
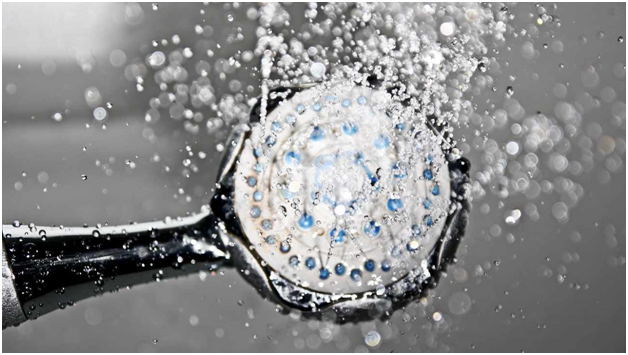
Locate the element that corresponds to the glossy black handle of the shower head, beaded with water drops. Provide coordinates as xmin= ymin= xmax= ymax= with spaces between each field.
xmin=2 ymin=210 xmax=230 ymax=329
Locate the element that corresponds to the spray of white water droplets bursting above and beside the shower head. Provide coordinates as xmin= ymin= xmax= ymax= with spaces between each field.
xmin=114 ymin=3 xmax=625 ymax=350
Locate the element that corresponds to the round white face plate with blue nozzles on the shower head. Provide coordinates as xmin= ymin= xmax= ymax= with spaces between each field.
xmin=233 ymin=82 xmax=451 ymax=295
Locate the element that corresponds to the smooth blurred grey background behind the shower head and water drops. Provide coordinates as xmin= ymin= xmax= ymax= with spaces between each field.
xmin=2 ymin=3 xmax=626 ymax=352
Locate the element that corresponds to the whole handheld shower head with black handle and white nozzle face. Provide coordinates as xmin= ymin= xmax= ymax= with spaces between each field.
xmin=3 ymin=79 xmax=469 ymax=327
